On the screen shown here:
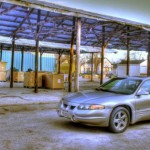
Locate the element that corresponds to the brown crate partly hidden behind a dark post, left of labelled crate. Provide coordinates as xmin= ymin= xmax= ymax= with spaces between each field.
xmin=24 ymin=71 xmax=45 ymax=88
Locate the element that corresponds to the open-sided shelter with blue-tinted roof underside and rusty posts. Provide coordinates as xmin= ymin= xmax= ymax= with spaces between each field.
xmin=0 ymin=0 xmax=150 ymax=93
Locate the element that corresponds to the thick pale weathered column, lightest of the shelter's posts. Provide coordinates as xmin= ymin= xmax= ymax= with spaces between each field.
xmin=75 ymin=18 xmax=81 ymax=92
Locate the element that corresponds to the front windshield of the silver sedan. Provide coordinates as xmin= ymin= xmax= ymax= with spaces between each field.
xmin=99 ymin=78 xmax=142 ymax=94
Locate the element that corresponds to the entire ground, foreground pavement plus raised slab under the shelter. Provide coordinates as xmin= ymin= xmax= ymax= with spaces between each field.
xmin=0 ymin=78 xmax=150 ymax=150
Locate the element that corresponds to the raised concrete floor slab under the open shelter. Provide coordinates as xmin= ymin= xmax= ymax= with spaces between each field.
xmin=0 ymin=79 xmax=99 ymax=109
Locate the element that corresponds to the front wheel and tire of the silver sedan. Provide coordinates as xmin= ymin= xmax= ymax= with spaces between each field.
xmin=109 ymin=107 xmax=130 ymax=133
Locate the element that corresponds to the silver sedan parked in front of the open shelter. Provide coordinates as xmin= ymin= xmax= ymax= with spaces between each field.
xmin=58 ymin=77 xmax=150 ymax=133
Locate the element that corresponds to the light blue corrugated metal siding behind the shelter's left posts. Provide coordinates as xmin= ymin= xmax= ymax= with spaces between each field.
xmin=2 ymin=50 xmax=56 ymax=72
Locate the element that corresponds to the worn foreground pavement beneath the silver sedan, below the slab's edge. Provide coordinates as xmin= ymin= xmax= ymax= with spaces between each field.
xmin=0 ymin=109 xmax=150 ymax=150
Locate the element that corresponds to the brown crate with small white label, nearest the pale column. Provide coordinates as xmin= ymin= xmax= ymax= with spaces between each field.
xmin=45 ymin=74 xmax=64 ymax=89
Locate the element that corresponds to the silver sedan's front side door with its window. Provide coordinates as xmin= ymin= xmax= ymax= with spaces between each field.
xmin=135 ymin=80 xmax=150 ymax=121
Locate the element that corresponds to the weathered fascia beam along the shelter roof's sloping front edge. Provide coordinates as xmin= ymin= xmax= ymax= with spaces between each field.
xmin=2 ymin=0 xmax=149 ymax=28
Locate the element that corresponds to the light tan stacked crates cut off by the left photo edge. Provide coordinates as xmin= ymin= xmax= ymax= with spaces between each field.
xmin=0 ymin=62 xmax=6 ymax=81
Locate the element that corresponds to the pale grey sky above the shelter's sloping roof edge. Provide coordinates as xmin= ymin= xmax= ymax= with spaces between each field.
xmin=41 ymin=0 xmax=150 ymax=25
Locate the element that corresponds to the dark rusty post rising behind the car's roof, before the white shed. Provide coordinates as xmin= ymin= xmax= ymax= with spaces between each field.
xmin=126 ymin=27 xmax=130 ymax=76
